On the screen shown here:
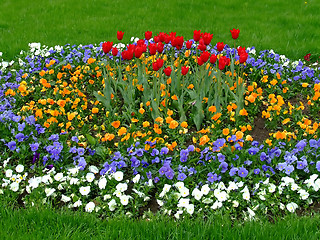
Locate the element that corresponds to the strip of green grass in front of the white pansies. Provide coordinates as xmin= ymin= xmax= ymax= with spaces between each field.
xmin=0 ymin=202 xmax=320 ymax=240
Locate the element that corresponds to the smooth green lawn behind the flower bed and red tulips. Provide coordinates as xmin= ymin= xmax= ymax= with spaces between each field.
xmin=0 ymin=0 xmax=320 ymax=60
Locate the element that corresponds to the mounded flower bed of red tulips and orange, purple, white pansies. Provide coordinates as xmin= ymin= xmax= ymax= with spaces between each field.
xmin=0 ymin=29 xmax=320 ymax=218
